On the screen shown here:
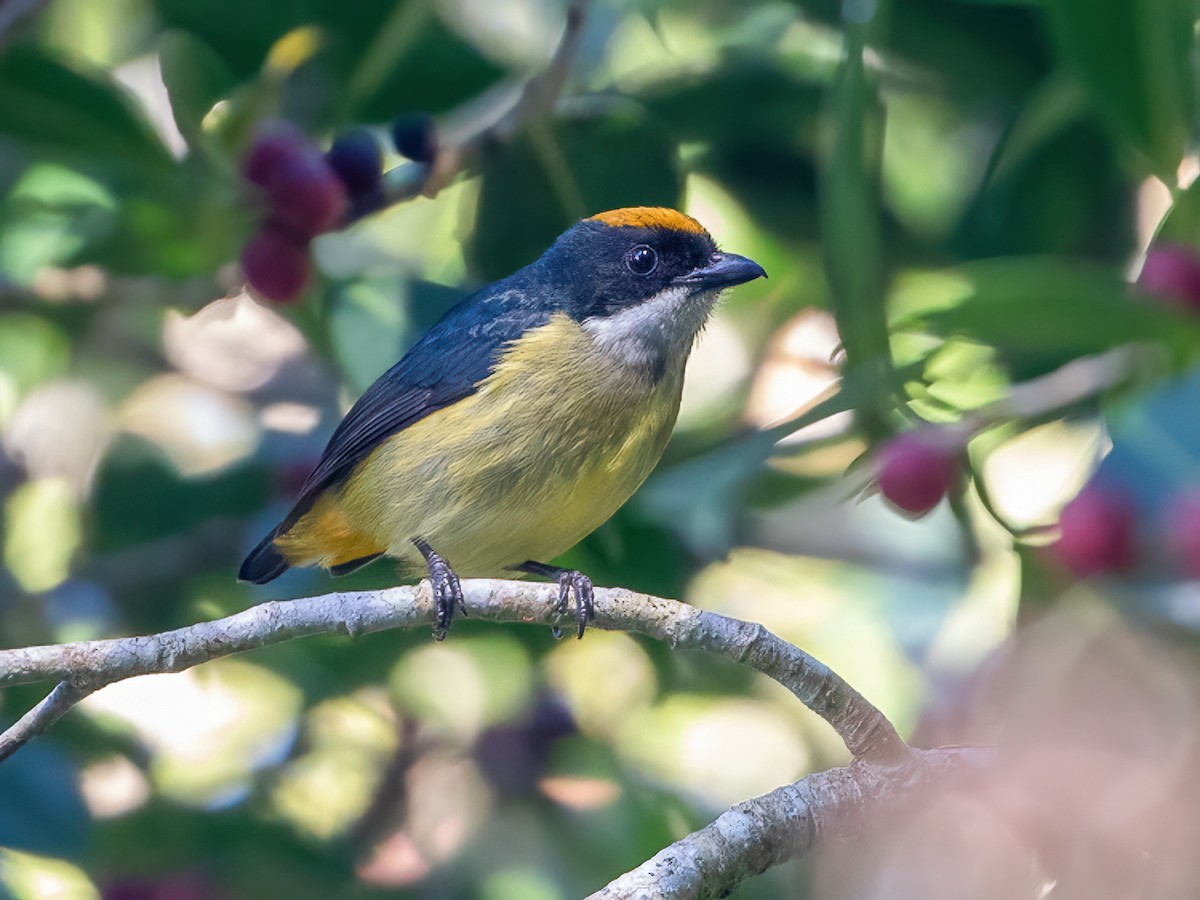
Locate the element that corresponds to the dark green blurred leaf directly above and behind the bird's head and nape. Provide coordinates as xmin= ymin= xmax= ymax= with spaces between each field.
xmin=468 ymin=107 xmax=683 ymax=281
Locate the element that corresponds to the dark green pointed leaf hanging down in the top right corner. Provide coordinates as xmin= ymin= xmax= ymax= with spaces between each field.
xmin=1045 ymin=0 xmax=1196 ymax=176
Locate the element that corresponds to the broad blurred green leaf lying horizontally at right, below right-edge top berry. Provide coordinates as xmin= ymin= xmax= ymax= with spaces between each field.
xmin=895 ymin=257 xmax=1200 ymax=377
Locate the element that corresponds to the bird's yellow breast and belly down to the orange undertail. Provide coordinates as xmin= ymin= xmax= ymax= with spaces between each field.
xmin=276 ymin=316 xmax=683 ymax=576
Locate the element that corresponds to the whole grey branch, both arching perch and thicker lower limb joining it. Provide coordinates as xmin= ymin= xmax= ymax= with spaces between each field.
xmin=0 ymin=580 xmax=936 ymax=898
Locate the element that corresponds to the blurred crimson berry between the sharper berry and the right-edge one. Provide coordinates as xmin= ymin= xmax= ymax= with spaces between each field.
xmin=1054 ymin=485 xmax=1136 ymax=577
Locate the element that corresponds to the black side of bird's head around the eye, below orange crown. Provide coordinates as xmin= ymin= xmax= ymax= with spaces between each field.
xmin=538 ymin=220 xmax=719 ymax=320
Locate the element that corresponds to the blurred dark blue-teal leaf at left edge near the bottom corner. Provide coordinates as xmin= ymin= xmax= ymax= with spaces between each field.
xmin=0 ymin=742 xmax=91 ymax=859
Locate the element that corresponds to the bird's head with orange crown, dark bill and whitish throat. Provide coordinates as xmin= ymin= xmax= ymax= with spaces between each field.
xmin=535 ymin=206 xmax=767 ymax=374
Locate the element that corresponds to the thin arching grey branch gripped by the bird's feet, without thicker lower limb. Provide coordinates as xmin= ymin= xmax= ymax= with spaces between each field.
xmin=0 ymin=580 xmax=911 ymax=762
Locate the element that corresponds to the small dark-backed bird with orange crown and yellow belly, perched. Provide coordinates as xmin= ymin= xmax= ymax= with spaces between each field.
xmin=239 ymin=206 xmax=766 ymax=640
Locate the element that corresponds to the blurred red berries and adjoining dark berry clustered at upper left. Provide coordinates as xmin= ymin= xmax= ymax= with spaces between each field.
xmin=241 ymin=121 xmax=383 ymax=302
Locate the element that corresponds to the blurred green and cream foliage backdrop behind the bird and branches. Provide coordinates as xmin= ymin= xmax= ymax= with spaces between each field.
xmin=7 ymin=0 xmax=1200 ymax=900
